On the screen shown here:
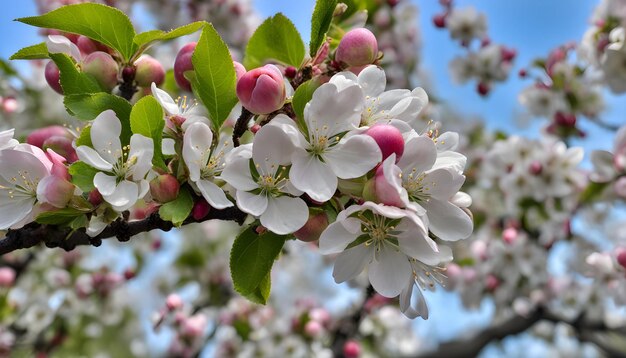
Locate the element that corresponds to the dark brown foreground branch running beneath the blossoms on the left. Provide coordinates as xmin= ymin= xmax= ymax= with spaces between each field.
xmin=0 ymin=207 xmax=247 ymax=255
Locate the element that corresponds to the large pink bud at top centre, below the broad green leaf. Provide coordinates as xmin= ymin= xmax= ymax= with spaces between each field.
xmin=237 ymin=65 xmax=287 ymax=114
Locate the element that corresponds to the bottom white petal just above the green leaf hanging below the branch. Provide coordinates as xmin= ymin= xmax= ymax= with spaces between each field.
xmin=261 ymin=196 xmax=309 ymax=235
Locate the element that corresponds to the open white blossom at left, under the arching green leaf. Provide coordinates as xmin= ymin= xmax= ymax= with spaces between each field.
xmin=76 ymin=110 xmax=154 ymax=212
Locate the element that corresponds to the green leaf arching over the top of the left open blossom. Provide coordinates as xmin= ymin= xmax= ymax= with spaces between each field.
xmin=63 ymin=92 xmax=132 ymax=146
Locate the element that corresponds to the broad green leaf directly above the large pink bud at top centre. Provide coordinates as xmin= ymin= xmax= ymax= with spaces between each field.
xmin=243 ymin=13 xmax=306 ymax=70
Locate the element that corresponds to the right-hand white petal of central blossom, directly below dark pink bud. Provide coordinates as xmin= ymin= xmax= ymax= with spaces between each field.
xmin=323 ymin=135 xmax=382 ymax=179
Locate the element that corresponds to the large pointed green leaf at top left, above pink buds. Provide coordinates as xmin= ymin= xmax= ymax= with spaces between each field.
xmin=17 ymin=3 xmax=136 ymax=61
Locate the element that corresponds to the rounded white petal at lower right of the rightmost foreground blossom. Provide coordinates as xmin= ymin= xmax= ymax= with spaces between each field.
xmin=422 ymin=199 xmax=474 ymax=241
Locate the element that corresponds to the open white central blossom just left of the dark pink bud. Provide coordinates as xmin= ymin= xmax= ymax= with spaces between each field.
xmin=270 ymin=75 xmax=381 ymax=202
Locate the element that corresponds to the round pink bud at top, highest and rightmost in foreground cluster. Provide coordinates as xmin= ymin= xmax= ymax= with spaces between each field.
xmin=335 ymin=28 xmax=378 ymax=66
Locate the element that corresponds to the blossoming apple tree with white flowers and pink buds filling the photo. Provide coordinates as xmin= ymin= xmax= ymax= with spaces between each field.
xmin=0 ymin=0 xmax=626 ymax=357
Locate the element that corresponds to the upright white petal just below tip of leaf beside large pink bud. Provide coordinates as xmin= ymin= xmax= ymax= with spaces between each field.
xmin=183 ymin=122 xmax=213 ymax=182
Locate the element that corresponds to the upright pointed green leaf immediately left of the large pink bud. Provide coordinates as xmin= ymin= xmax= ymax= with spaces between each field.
xmin=190 ymin=24 xmax=238 ymax=130
